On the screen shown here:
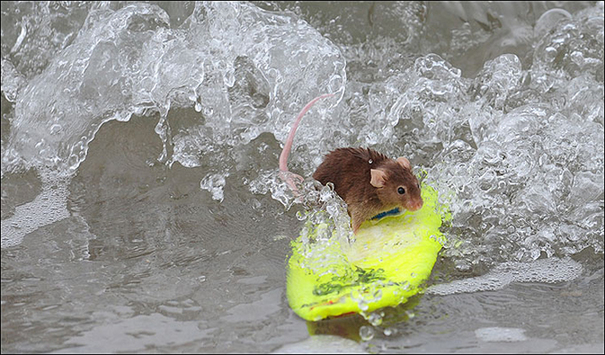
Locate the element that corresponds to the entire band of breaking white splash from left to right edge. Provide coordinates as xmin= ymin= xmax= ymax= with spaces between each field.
xmin=2 ymin=3 xmax=603 ymax=278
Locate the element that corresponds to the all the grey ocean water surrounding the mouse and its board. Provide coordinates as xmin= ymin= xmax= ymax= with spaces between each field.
xmin=0 ymin=1 xmax=604 ymax=353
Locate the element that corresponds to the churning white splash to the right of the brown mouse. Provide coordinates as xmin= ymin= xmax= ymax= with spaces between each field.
xmin=268 ymin=2 xmax=604 ymax=280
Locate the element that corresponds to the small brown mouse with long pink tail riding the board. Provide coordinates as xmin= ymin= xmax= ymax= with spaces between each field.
xmin=279 ymin=94 xmax=423 ymax=234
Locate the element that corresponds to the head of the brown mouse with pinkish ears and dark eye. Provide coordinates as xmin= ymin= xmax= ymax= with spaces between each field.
xmin=370 ymin=157 xmax=423 ymax=211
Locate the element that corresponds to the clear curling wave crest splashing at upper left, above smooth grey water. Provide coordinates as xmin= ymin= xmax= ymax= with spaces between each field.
xmin=2 ymin=3 xmax=345 ymax=177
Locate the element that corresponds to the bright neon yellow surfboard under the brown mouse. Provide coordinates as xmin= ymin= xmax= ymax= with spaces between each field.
xmin=286 ymin=185 xmax=448 ymax=321
